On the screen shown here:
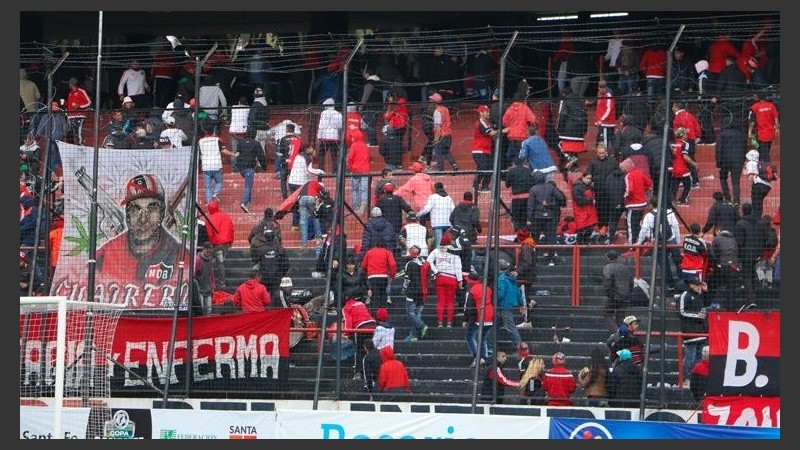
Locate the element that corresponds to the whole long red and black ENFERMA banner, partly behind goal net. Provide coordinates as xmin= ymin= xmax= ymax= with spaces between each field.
xmin=20 ymin=308 xmax=293 ymax=396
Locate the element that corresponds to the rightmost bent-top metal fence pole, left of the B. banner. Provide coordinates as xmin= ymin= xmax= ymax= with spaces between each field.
xmin=639 ymin=25 xmax=686 ymax=420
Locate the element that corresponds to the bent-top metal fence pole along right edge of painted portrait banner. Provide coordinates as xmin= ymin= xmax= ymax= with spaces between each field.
xmin=161 ymin=43 xmax=217 ymax=409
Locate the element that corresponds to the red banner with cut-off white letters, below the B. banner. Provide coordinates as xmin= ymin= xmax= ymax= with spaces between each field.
xmin=700 ymin=397 xmax=781 ymax=427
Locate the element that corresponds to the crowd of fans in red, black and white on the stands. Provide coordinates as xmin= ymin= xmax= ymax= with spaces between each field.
xmin=20 ymin=28 xmax=780 ymax=406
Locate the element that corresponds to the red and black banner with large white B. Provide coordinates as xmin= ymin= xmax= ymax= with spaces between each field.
xmin=706 ymin=312 xmax=781 ymax=397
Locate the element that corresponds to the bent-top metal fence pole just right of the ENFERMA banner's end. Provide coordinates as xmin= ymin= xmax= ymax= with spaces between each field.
xmin=311 ymin=38 xmax=364 ymax=411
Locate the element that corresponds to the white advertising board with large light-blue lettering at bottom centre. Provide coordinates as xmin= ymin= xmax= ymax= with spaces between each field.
xmin=275 ymin=411 xmax=550 ymax=439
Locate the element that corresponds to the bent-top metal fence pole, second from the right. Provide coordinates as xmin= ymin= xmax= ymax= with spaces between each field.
xmin=470 ymin=31 xmax=519 ymax=414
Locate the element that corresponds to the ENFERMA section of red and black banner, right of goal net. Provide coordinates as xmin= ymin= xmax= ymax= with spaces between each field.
xmin=111 ymin=308 xmax=292 ymax=394
